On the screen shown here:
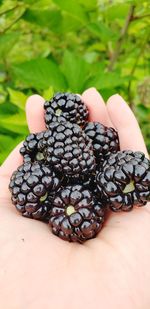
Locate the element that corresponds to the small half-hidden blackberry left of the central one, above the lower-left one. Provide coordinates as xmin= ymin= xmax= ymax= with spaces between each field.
xmin=20 ymin=132 xmax=45 ymax=162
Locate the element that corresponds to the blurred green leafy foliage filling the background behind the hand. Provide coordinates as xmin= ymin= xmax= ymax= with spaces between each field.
xmin=0 ymin=0 xmax=150 ymax=162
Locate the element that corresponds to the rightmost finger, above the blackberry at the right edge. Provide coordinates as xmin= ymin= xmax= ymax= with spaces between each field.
xmin=107 ymin=94 xmax=148 ymax=156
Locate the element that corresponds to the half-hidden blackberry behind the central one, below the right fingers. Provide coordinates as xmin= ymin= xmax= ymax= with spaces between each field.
xmin=84 ymin=122 xmax=119 ymax=165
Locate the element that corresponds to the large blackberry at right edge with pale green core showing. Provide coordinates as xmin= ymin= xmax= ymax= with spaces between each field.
xmin=97 ymin=150 xmax=150 ymax=211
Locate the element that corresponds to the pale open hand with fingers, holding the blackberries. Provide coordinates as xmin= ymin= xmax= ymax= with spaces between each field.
xmin=0 ymin=88 xmax=150 ymax=309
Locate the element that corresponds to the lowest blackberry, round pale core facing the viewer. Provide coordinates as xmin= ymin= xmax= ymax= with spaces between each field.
xmin=49 ymin=185 xmax=105 ymax=243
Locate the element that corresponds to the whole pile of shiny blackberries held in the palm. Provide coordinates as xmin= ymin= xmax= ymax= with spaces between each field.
xmin=9 ymin=93 xmax=150 ymax=243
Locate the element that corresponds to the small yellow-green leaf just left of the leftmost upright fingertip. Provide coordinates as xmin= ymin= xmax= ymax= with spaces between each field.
xmin=7 ymin=88 xmax=27 ymax=110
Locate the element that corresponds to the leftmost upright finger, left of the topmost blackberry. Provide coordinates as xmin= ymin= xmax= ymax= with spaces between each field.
xmin=26 ymin=94 xmax=46 ymax=133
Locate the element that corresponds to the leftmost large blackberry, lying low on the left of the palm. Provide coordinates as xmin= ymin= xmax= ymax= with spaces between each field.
xmin=9 ymin=162 xmax=61 ymax=221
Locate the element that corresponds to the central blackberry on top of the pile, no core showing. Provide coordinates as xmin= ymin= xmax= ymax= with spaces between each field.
xmin=43 ymin=122 xmax=95 ymax=177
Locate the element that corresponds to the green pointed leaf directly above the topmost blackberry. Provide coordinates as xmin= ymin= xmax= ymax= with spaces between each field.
xmin=62 ymin=50 xmax=89 ymax=92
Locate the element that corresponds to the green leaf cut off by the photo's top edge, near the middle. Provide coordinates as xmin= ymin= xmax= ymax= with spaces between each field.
xmin=53 ymin=0 xmax=88 ymax=24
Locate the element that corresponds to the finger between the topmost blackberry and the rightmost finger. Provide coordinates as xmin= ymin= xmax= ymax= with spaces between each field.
xmin=82 ymin=88 xmax=113 ymax=127
